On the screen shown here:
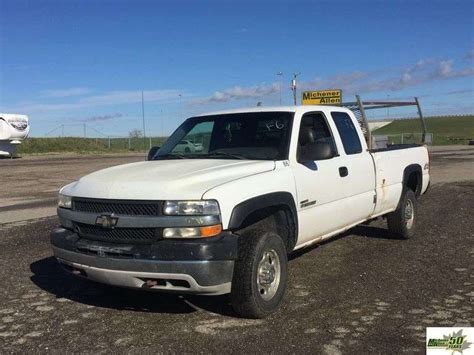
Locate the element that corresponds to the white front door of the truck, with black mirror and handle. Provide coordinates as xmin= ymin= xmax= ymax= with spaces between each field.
xmin=292 ymin=112 xmax=354 ymax=245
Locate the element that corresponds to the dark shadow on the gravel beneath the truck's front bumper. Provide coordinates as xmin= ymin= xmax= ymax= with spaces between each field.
xmin=30 ymin=256 xmax=235 ymax=316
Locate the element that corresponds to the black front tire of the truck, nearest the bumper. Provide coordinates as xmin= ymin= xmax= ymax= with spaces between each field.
xmin=231 ymin=230 xmax=288 ymax=319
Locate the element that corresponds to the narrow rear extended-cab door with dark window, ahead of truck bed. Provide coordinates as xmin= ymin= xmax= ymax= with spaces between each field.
xmin=331 ymin=111 xmax=376 ymax=224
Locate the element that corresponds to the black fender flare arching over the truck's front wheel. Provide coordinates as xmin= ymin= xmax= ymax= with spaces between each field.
xmin=228 ymin=191 xmax=298 ymax=238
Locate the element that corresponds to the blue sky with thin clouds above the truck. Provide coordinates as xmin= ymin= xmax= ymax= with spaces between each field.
xmin=0 ymin=0 xmax=474 ymax=136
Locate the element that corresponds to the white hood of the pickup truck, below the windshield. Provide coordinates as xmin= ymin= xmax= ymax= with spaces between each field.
xmin=61 ymin=159 xmax=275 ymax=200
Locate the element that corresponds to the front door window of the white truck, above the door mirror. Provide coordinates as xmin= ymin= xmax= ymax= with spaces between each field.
xmin=298 ymin=112 xmax=337 ymax=155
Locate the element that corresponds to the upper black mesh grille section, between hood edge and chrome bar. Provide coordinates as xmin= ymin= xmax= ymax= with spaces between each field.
xmin=72 ymin=197 xmax=163 ymax=216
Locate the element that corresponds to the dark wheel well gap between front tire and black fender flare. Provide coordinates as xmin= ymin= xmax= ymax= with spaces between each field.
xmin=236 ymin=205 xmax=297 ymax=253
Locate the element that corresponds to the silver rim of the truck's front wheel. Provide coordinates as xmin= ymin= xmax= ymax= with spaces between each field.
xmin=257 ymin=249 xmax=281 ymax=301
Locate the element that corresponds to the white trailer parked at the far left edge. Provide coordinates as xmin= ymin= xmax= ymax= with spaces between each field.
xmin=0 ymin=113 xmax=30 ymax=157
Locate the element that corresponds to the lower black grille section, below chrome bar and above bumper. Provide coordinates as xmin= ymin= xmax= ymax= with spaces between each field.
xmin=74 ymin=223 xmax=159 ymax=244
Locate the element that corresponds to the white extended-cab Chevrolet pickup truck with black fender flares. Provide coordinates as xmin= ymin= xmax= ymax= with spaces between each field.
xmin=51 ymin=106 xmax=430 ymax=318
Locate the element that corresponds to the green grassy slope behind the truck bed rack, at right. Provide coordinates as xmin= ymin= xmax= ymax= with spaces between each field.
xmin=372 ymin=115 xmax=474 ymax=145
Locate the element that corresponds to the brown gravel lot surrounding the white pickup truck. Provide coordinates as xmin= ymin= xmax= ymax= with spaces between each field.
xmin=0 ymin=149 xmax=474 ymax=354
